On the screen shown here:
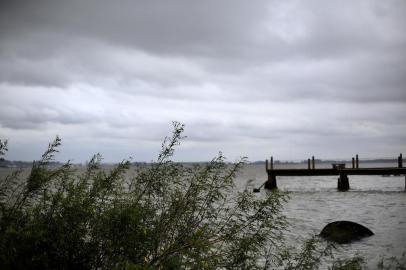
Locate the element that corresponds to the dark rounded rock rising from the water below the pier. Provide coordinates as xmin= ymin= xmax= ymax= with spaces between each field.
xmin=320 ymin=220 xmax=374 ymax=244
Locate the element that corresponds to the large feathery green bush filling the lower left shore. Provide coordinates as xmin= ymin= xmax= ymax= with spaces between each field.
xmin=0 ymin=123 xmax=285 ymax=269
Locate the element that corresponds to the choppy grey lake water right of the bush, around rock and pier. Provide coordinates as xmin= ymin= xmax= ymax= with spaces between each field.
xmin=237 ymin=163 xmax=406 ymax=269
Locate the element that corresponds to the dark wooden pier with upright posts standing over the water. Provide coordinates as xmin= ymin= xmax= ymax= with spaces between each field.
xmin=264 ymin=154 xmax=406 ymax=191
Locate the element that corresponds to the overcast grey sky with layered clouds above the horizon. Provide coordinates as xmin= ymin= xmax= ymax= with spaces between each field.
xmin=0 ymin=0 xmax=406 ymax=162
